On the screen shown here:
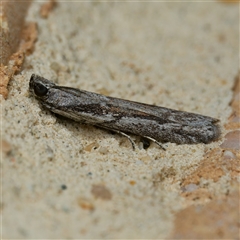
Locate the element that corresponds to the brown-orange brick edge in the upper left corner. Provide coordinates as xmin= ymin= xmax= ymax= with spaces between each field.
xmin=0 ymin=0 xmax=37 ymax=99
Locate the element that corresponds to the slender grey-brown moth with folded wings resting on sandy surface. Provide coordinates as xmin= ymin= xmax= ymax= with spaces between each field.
xmin=29 ymin=74 xmax=221 ymax=149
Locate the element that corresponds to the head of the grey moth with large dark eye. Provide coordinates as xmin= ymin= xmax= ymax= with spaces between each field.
xmin=29 ymin=74 xmax=55 ymax=98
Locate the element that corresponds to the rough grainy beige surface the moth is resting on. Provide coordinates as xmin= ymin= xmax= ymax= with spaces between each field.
xmin=1 ymin=2 xmax=240 ymax=239
